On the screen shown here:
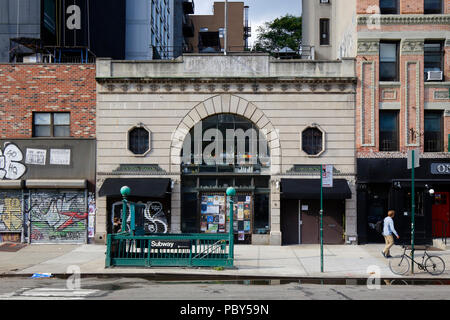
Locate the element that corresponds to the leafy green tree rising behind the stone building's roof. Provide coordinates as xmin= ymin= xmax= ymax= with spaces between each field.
xmin=253 ymin=14 xmax=302 ymax=53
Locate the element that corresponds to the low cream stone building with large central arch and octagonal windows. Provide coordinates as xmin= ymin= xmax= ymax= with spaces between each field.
xmin=96 ymin=54 xmax=357 ymax=245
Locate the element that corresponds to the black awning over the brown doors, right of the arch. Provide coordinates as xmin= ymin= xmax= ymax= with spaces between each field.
xmin=281 ymin=179 xmax=352 ymax=200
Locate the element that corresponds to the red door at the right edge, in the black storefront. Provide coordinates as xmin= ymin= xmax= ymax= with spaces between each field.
xmin=432 ymin=192 xmax=450 ymax=237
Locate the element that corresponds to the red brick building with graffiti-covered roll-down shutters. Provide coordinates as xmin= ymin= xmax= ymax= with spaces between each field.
xmin=0 ymin=64 xmax=96 ymax=243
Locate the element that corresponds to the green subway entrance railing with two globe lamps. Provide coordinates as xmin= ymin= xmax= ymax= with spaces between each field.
xmin=105 ymin=186 xmax=236 ymax=268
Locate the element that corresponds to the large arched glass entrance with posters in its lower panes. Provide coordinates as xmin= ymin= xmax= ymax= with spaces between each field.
xmin=180 ymin=113 xmax=271 ymax=243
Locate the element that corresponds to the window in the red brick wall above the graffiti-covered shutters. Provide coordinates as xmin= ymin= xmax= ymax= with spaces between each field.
xmin=33 ymin=112 xmax=70 ymax=137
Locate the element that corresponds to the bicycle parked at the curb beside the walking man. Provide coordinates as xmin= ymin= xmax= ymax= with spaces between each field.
xmin=389 ymin=246 xmax=445 ymax=276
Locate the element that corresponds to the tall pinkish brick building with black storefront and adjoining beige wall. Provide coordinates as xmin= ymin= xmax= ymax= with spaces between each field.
xmin=303 ymin=0 xmax=450 ymax=243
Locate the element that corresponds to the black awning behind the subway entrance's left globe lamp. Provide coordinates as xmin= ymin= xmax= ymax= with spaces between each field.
xmin=98 ymin=178 xmax=170 ymax=198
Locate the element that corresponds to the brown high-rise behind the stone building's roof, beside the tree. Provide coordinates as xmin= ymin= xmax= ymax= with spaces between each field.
xmin=188 ymin=2 xmax=250 ymax=53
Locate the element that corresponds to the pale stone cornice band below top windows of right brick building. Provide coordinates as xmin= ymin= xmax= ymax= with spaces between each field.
xmin=357 ymin=14 xmax=450 ymax=25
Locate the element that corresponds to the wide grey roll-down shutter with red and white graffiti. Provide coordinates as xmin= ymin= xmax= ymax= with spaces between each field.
xmin=29 ymin=190 xmax=88 ymax=243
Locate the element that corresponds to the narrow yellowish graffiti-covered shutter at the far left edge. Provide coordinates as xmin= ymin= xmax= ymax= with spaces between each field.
xmin=0 ymin=190 xmax=23 ymax=233
